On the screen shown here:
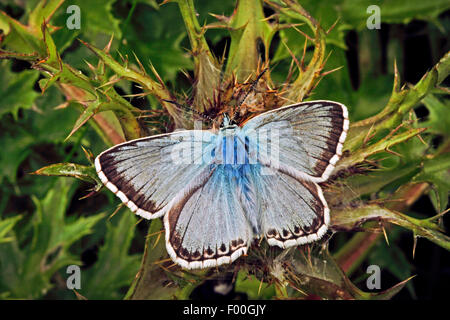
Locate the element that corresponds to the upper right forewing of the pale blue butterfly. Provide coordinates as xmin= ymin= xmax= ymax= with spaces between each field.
xmin=243 ymin=101 xmax=349 ymax=182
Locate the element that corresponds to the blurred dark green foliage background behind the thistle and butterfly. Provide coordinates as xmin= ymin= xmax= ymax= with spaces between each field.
xmin=0 ymin=0 xmax=450 ymax=299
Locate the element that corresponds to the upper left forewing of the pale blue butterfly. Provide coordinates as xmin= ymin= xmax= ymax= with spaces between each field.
xmin=95 ymin=130 xmax=216 ymax=219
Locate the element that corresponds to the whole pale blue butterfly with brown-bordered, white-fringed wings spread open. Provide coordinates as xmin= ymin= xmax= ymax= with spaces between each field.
xmin=95 ymin=100 xmax=349 ymax=269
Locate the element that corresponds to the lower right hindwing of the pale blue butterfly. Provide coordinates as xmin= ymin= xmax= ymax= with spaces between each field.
xmin=249 ymin=167 xmax=330 ymax=248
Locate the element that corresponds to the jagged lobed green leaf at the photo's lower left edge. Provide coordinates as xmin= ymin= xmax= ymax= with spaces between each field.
xmin=0 ymin=179 xmax=104 ymax=299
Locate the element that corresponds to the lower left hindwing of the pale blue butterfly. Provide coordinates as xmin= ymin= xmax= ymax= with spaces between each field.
xmin=164 ymin=165 xmax=253 ymax=269
